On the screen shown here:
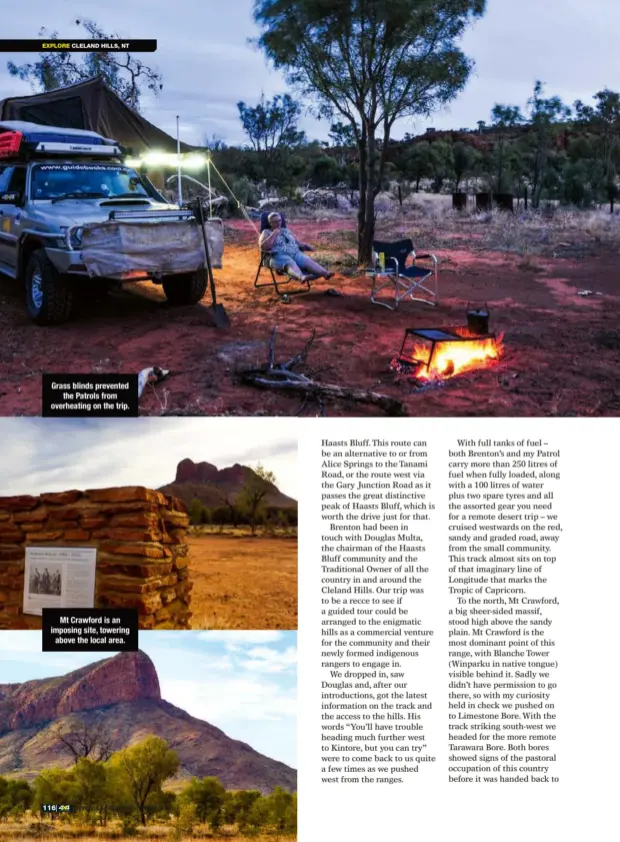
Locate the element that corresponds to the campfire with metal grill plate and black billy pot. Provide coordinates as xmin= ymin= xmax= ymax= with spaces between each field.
xmin=392 ymin=306 xmax=503 ymax=380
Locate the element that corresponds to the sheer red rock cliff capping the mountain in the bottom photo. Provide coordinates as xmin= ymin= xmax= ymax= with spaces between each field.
xmin=0 ymin=651 xmax=161 ymax=733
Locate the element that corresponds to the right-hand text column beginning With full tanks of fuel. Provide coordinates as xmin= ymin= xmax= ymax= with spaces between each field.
xmin=448 ymin=439 xmax=562 ymax=784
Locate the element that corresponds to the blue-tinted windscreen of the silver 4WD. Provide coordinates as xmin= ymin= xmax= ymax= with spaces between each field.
xmin=30 ymin=164 xmax=161 ymax=201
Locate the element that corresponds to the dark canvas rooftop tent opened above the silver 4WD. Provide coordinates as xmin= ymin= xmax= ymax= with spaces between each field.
xmin=0 ymin=76 xmax=195 ymax=154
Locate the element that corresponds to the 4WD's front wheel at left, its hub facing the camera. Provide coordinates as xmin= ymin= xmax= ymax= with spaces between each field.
xmin=25 ymin=249 xmax=73 ymax=325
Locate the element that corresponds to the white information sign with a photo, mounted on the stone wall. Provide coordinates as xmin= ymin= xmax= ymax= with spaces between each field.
xmin=24 ymin=547 xmax=97 ymax=616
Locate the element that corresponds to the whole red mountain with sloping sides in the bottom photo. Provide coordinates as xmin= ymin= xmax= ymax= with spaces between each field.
xmin=0 ymin=652 xmax=297 ymax=792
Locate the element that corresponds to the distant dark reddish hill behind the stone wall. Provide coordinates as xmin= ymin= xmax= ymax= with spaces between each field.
xmin=159 ymin=459 xmax=297 ymax=509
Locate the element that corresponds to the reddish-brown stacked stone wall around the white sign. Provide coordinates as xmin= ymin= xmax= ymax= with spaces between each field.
xmin=0 ymin=487 xmax=192 ymax=629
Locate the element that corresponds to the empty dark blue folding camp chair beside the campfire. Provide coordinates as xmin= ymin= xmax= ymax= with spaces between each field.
xmin=368 ymin=240 xmax=439 ymax=310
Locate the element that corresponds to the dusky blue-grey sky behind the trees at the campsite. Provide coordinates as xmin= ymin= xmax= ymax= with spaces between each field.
xmin=0 ymin=0 xmax=620 ymax=144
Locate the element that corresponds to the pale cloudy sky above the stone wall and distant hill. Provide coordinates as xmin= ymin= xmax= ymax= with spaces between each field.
xmin=0 ymin=418 xmax=298 ymax=500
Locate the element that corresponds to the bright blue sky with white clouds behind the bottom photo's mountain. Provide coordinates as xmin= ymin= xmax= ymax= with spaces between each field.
xmin=0 ymin=631 xmax=297 ymax=768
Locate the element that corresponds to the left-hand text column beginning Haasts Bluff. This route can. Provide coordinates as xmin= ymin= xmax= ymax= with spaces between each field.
xmin=321 ymin=439 xmax=436 ymax=784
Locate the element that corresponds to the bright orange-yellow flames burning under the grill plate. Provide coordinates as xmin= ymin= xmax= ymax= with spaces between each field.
xmin=400 ymin=327 xmax=504 ymax=380
